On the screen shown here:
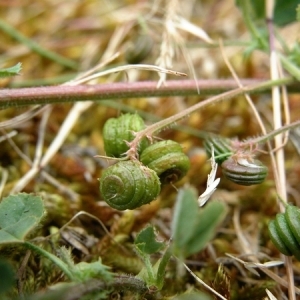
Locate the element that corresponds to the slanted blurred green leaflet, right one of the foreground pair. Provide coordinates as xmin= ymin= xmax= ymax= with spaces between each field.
xmin=185 ymin=201 xmax=227 ymax=256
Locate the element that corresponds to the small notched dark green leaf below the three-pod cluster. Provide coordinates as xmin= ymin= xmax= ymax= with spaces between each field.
xmin=134 ymin=226 xmax=164 ymax=254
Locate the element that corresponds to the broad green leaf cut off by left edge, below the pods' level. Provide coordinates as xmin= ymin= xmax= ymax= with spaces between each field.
xmin=0 ymin=193 xmax=44 ymax=244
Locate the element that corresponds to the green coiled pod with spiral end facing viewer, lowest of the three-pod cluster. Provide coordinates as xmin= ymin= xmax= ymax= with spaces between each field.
xmin=100 ymin=160 xmax=160 ymax=210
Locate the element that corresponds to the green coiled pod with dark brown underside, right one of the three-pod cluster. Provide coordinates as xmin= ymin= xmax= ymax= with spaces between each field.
xmin=140 ymin=140 xmax=190 ymax=183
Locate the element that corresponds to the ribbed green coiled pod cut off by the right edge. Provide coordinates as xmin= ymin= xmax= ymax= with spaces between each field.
xmin=268 ymin=205 xmax=300 ymax=261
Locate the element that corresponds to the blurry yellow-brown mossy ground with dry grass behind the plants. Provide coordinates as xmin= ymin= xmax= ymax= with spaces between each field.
xmin=0 ymin=0 xmax=300 ymax=299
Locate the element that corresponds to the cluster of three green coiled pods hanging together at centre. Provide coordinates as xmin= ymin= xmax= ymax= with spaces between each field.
xmin=100 ymin=114 xmax=190 ymax=210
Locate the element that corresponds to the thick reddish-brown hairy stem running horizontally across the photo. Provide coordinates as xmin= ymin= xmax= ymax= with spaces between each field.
xmin=0 ymin=79 xmax=299 ymax=108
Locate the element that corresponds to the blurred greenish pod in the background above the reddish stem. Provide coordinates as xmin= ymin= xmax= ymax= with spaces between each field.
xmin=125 ymin=34 xmax=153 ymax=64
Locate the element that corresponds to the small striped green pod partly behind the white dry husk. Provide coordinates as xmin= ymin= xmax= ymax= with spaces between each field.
xmin=204 ymin=134 xmax=232 ymax=164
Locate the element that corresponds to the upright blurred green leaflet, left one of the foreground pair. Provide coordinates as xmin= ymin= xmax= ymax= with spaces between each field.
xmin=171 ymin=187 xmax=199 ymax=252
